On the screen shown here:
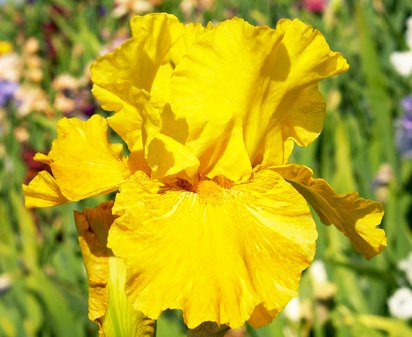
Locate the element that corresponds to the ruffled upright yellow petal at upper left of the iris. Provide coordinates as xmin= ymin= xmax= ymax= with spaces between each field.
xmin=91 ymin=14 xmax=183 ymax=151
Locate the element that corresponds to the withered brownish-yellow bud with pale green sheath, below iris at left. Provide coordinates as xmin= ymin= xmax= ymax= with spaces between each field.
xmin=74 ymin=201 xmax=154 ymax=337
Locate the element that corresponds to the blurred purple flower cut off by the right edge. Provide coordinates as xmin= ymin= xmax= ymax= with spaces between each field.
xmin=396 ymin=95 xmax=412 ymax=158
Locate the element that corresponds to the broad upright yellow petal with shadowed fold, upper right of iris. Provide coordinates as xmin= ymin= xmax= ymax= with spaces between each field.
xmin=171 ymin=18 xmax=348 ymax=181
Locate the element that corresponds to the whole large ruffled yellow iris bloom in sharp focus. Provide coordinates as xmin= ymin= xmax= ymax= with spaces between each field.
xmin=24 ymin=14 xmax=386 ymax=328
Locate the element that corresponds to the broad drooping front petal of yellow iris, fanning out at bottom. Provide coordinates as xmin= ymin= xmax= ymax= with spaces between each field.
xmin=108 ymin=170 xmax=317 ymax=328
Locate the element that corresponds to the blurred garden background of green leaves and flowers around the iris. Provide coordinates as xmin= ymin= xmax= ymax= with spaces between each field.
xmin=0 ymin=0 xmax=412 ymax=337
